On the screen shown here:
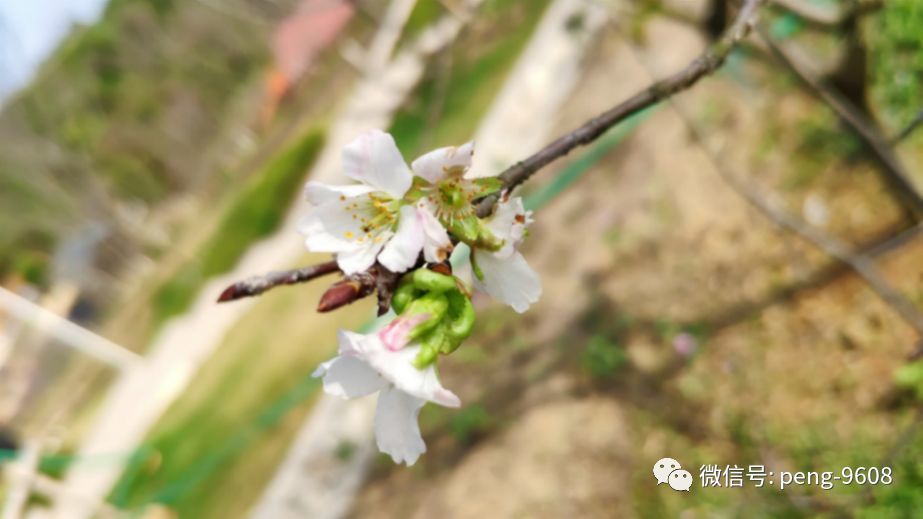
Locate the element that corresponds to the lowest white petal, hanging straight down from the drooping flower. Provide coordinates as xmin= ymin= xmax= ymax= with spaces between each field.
xmin=375 ymin=387 xmax=426 ymax=466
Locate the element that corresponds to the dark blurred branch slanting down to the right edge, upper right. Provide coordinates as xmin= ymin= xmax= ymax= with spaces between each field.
xmin=756 ymin=25 xmax=923 ymax=221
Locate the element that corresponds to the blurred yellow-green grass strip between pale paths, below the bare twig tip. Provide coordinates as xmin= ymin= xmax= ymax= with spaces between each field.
xmin=110 ymin=268 xmax=371 ymax=519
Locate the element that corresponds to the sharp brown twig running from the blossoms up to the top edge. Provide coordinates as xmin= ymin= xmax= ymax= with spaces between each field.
xmin=478 ymin=0 xmax=764 ymax=217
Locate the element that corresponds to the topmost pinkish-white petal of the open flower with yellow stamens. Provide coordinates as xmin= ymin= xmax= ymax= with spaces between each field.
xmin=343 ymin=130 xmax=413 ymax=198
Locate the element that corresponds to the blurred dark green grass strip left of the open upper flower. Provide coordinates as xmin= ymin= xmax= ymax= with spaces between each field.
xmin=153 ymin=130 xmax=324 ymax=323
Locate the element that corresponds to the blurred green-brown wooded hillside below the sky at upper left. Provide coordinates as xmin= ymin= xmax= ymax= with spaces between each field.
xmin=0 ymin=0 xmax=270 ymax=284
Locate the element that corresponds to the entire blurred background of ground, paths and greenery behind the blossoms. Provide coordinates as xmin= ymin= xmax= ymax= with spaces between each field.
xmin=0 ymin=0 xmax=923 ymax=519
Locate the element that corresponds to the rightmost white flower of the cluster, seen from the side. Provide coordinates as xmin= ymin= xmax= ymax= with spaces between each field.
xmin=471 ymin=197 xmax=542 ymax=313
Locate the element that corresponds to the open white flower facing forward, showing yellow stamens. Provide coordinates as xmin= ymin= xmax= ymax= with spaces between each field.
xmin=300 ymin=130 xmax=452 ymax=274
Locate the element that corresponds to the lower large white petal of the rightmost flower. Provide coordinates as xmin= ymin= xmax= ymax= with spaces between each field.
xmin=474 ymin=252 xmax=542 ymax=313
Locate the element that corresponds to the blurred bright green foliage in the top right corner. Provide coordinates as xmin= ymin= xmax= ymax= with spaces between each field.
xmin=868 ymin=0 xmax=923 ymax=128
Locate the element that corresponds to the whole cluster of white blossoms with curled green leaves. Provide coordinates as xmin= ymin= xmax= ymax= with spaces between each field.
xmin=300 ymin=130 xmax=541 ymax=465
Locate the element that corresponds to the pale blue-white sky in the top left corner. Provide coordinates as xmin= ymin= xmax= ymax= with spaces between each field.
xmin=0 ymin=0 xmax=107 ymax=103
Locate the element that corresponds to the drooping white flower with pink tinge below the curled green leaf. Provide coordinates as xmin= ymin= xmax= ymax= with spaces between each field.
xmin=314 ymin=328 xmax=461 ymax=465
